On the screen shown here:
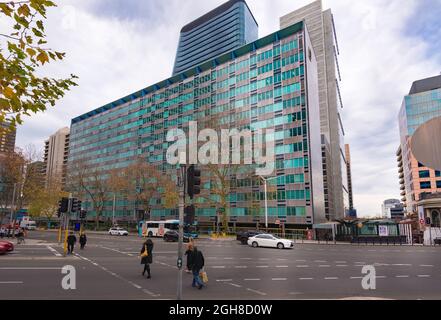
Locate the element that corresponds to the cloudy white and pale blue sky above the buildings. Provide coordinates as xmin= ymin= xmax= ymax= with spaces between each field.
xmin=12 ymin=0 xmax=441 ymax=216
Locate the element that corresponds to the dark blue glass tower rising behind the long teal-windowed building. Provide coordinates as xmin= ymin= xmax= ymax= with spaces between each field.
xmin=173 ymin=0 xmax=258 ymax=75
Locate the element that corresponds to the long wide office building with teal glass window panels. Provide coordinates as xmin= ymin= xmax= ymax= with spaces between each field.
xmin=69 ymin=22 xmax=325 ymax=227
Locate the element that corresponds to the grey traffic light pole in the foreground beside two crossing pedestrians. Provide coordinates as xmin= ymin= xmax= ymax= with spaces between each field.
xmin=177 ymin=166 xmax=187 ymax=300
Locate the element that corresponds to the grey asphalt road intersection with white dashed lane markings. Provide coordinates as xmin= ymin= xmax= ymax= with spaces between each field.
xmin=0 ymin=231 xmax=441 ymax=300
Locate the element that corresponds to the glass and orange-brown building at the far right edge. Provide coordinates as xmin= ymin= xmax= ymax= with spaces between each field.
xmin=397 ymin=76 xmax=441 ymax=213
